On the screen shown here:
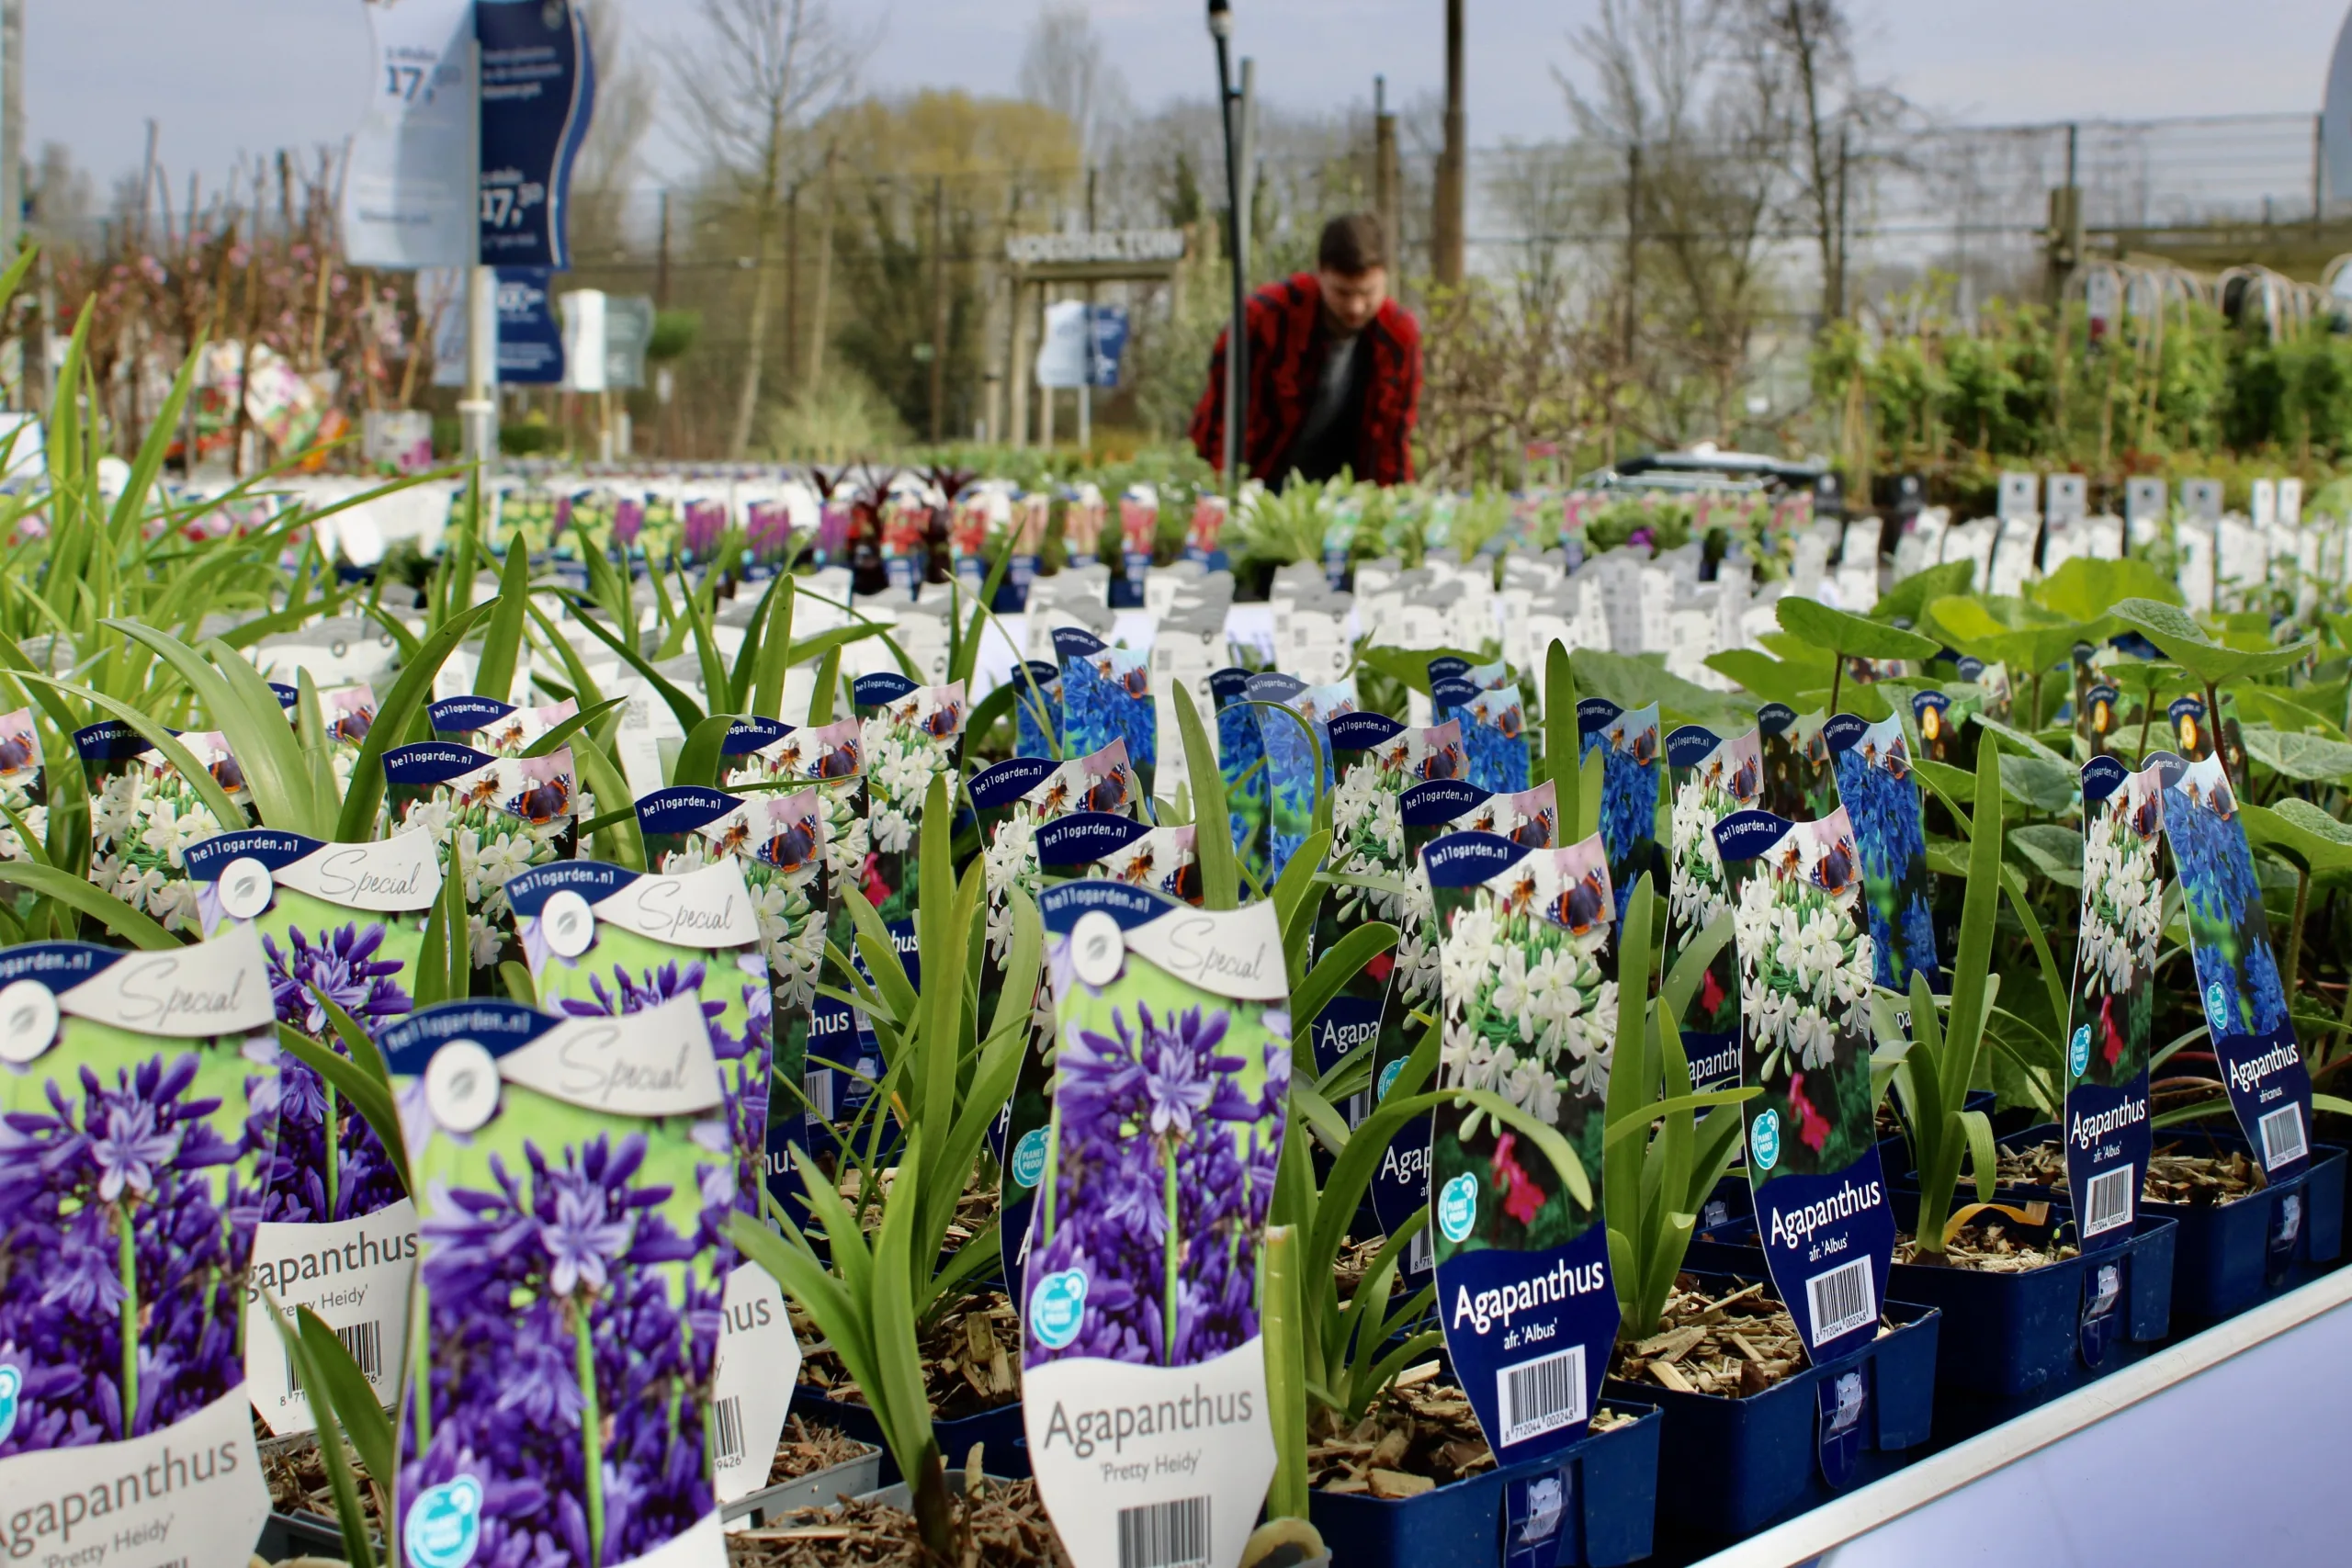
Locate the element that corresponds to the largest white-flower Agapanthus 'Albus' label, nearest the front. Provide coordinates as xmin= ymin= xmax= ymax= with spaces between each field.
xmin=1420 ymin=832 xmax=1642 ymax=1464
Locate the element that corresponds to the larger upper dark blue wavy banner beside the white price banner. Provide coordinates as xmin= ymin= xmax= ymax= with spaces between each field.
xmin=473 ymin=0 xmax=595 ymax=267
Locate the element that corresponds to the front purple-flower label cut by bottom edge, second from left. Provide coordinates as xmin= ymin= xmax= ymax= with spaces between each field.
xmin=381 ymin=995 xmax=743 ymax=1568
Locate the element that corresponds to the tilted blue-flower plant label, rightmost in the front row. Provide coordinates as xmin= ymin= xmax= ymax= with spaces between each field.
xmin=2154 ymin=755 xmax=2312 ymax=1180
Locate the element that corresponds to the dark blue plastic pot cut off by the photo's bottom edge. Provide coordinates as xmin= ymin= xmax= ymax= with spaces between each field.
xmin=1307 ymin=1389 xmax=1665 ymax=1568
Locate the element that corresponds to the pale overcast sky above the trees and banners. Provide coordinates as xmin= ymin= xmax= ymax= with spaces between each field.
xmin=24 ymin=0 xmax=2345 ymax=197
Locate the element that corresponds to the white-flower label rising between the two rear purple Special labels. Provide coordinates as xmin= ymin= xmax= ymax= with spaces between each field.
xmin=383 ymin=740 xmax=579 ymax=995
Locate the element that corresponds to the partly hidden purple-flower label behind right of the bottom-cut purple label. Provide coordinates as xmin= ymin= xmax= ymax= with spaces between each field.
xmin=505 ymin=853 xmax=799 ymax=1502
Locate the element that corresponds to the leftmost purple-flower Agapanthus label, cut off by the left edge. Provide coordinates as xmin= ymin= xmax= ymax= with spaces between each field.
xmin=0 ymin=929 xmax=277 ymax=1565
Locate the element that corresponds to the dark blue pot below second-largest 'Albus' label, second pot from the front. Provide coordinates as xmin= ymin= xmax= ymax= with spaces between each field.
xmin=1601 ymin=1279 xmax=1940 ymax=1535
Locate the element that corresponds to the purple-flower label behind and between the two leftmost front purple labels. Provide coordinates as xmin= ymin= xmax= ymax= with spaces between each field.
xmin=188 ymin=828 xmax=442 ymax=1437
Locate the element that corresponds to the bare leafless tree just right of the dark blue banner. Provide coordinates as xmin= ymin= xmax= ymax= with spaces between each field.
xmin=668 ymin=0 xmax=873 ymax=458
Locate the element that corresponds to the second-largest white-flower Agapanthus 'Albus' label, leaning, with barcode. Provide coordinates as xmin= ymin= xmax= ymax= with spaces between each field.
xmin=1714 ymin=811 xmax=1895 ymax=1363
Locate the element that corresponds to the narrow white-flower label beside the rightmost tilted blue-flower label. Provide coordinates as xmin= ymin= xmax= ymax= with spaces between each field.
xmin=2065 ymin=757 xmax=2164 ymax=1253
